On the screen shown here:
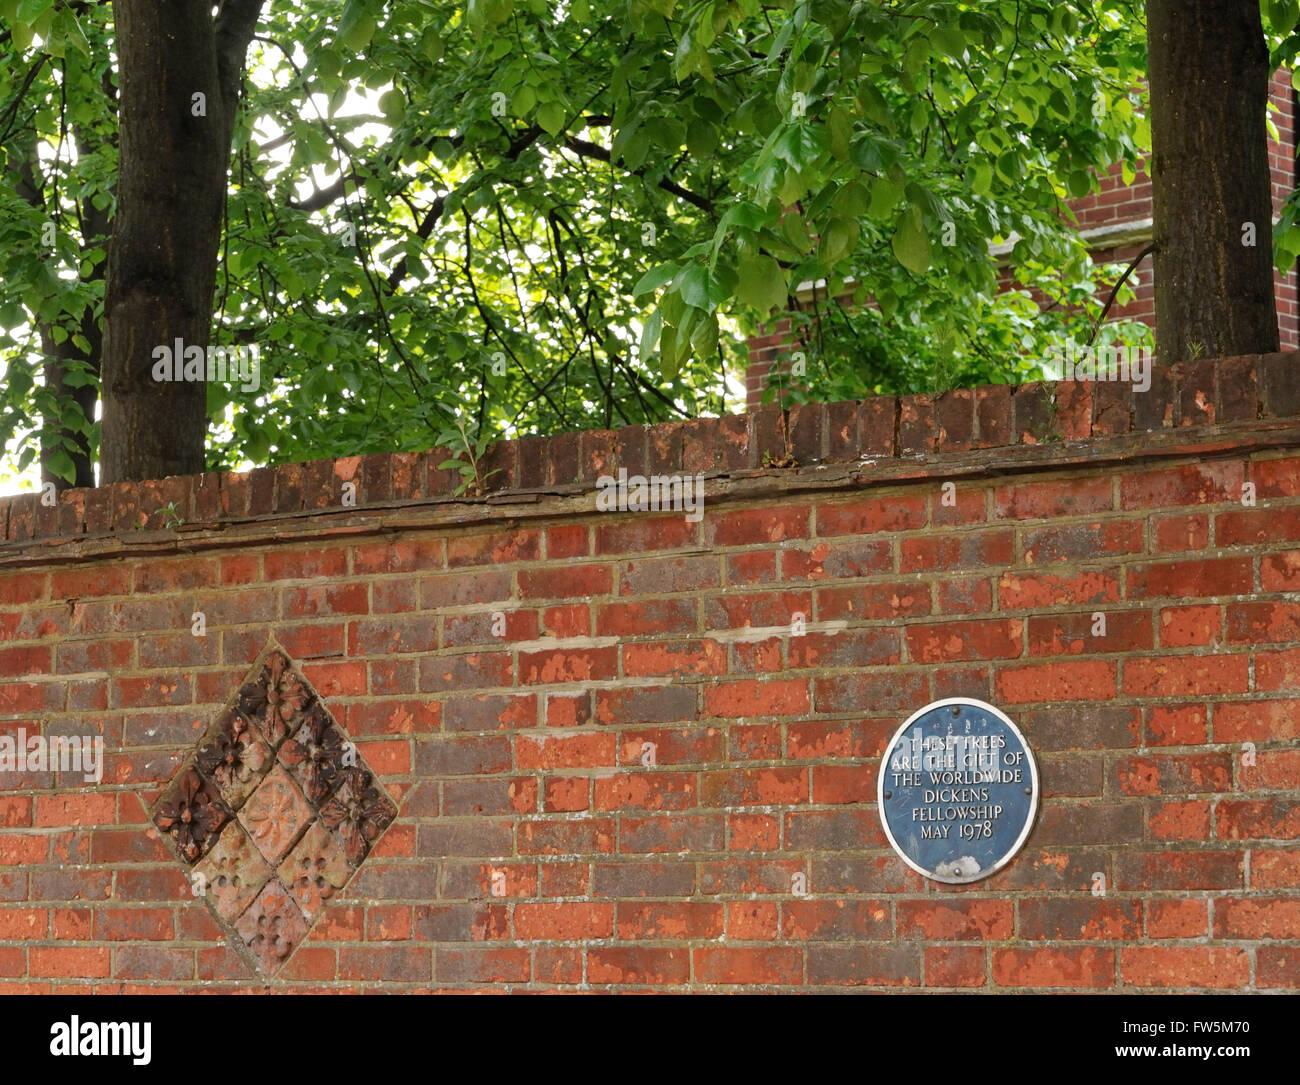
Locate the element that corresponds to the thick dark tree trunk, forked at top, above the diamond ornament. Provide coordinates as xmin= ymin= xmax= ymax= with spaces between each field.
xmin=100 ymin=0 xmax=261 ymax=483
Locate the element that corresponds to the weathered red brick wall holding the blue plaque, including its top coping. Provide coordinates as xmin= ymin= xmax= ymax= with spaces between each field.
xmin=0 ymin=355 xmax=1300 ymax=991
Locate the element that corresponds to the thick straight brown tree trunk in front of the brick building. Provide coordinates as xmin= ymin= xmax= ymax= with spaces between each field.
xmin=1147 ymin=0 xmax=1278 ymax=364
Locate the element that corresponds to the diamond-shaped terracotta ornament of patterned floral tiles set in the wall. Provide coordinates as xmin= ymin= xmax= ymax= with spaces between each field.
xmin=152 ymin=650 xmax=397 ymax=976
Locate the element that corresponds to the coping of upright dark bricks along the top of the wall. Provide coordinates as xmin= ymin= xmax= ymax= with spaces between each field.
xmin=0 ymin=353 xmax=1300 ymax=564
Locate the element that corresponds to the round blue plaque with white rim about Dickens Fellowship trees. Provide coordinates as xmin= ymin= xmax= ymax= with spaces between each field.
xmin=876 ymin=696 xmax=1039 ymax=884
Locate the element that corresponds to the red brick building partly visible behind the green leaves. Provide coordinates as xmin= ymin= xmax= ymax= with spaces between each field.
xmin=746 ymin=70 xmax=1300 ymax=411
